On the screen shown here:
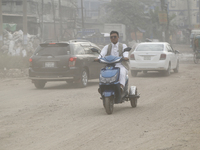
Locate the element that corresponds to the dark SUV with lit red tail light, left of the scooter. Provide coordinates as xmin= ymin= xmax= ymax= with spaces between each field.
xmin=29 ymin=40 xmax=102 ymax=89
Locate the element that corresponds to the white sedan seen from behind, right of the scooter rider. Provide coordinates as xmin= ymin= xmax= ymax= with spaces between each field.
xmin=130 ymin=42 xmax=179 ymax=77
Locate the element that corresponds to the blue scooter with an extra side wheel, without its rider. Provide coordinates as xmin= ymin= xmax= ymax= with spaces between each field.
xmin=91 ymin=47 xmax=140 ymax=114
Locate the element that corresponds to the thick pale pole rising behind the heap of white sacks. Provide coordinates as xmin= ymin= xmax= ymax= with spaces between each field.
xmin=23 ymin=0 xmax=28 ymax=48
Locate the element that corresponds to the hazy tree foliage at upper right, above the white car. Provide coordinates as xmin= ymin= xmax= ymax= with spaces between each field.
xmin=105 ymin=0 xmax=175 ymax=39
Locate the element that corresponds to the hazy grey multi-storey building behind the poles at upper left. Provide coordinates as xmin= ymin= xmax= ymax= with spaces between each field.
xmin=2 ymin=0 xmax=77 ymax=39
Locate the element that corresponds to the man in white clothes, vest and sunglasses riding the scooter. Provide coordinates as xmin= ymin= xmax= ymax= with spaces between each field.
xmin=95 ymin=31 xmax=129 ymax=92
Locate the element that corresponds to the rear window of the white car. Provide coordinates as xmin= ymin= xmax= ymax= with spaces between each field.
xmin=136 ymin=44 xmax=164 ymax=51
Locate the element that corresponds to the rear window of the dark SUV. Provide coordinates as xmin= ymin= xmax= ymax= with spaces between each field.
xmin=35 ymin=45 xmax=70 ymax=56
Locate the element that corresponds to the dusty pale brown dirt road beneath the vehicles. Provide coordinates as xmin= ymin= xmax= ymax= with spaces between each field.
xmin=0 ymin=44 xmax=200 ymax=150
